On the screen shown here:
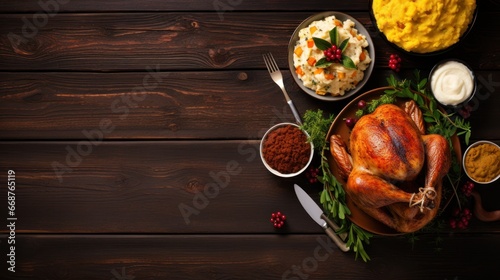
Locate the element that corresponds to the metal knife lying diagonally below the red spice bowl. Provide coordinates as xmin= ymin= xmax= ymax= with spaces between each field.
xmin=294 ymin=184 xmax=349 ymax=252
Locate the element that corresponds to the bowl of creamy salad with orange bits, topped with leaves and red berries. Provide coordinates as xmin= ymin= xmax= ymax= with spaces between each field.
xmin=288 ymin=11 xmax=375 ymax=101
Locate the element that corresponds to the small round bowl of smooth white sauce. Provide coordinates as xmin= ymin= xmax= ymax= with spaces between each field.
xmin=431 ymin=61 xmax=474 ymax=105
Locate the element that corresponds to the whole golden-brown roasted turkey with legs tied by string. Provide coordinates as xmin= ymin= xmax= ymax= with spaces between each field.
xmin=330 ymin=101 xmax=451 ymax=233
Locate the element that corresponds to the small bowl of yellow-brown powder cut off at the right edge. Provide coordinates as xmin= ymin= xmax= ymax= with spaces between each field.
xmin=463 ymin=140 xmax=500 ymax=184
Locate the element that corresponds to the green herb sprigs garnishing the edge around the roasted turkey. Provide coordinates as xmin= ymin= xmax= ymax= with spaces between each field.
xmin=303 ymin=70 xmax=471 ymax=262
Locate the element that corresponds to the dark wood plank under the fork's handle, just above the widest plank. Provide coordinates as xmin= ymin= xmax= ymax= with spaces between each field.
xmin=0 ymin=70 xmax=500 ymax=140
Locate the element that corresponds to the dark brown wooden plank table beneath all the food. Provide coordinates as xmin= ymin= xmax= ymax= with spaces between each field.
xmin=0 ymin=0 xmax=500 ymax=280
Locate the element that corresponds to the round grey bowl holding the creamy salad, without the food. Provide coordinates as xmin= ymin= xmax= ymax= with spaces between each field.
xmin=288 ymin=11 xmax=375 ymax=101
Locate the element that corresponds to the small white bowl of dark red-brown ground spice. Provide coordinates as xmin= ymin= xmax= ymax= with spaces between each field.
xmin=260 ymin=123 xmax=314 ymax=177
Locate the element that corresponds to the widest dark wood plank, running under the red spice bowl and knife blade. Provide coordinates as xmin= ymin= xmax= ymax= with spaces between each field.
xmin=0 ymin=140 xmax=500 ymax=233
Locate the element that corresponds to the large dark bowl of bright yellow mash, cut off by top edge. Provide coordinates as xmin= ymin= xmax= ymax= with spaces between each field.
xmin=370 ymin=0 xmax=477 ymax=55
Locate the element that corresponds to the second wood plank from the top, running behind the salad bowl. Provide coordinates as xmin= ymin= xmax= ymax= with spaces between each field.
xmin=0 ymin=9 xmax=500 ymax=71
